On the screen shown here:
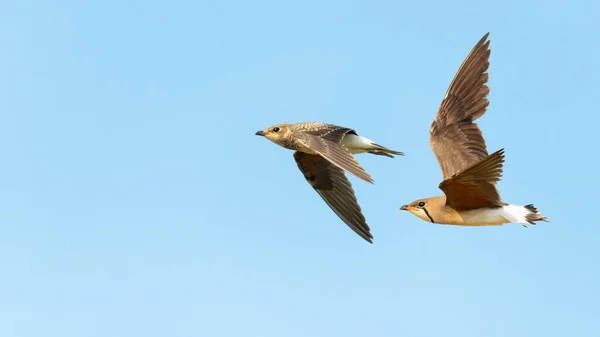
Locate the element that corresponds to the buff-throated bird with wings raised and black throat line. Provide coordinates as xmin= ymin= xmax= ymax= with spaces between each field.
xmin=400 ymin=33 xmax=547 ymax=226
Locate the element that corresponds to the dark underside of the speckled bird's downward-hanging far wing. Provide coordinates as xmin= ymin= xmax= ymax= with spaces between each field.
xmin=294 ymin=151 xmax=373 ymax=243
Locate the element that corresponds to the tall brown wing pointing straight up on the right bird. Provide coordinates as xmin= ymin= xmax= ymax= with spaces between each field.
xmin=429 ymin=33 xmax=490 ymax=179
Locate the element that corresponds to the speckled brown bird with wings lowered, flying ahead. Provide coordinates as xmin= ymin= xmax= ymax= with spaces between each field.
xmin=256 ymin=122 xmax=404 ymax=243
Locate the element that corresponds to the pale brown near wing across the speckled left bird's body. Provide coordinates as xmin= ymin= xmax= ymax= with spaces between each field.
xmin=298 ymin=123 xmax=374 ymax=183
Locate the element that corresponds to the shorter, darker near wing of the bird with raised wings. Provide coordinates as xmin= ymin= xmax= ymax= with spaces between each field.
xmin=439 ymin=149 xmax=504 ymax=211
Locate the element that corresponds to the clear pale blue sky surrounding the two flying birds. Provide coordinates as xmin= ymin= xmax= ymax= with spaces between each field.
xmin=0 ymin=0 xmax=600 ymax=337
